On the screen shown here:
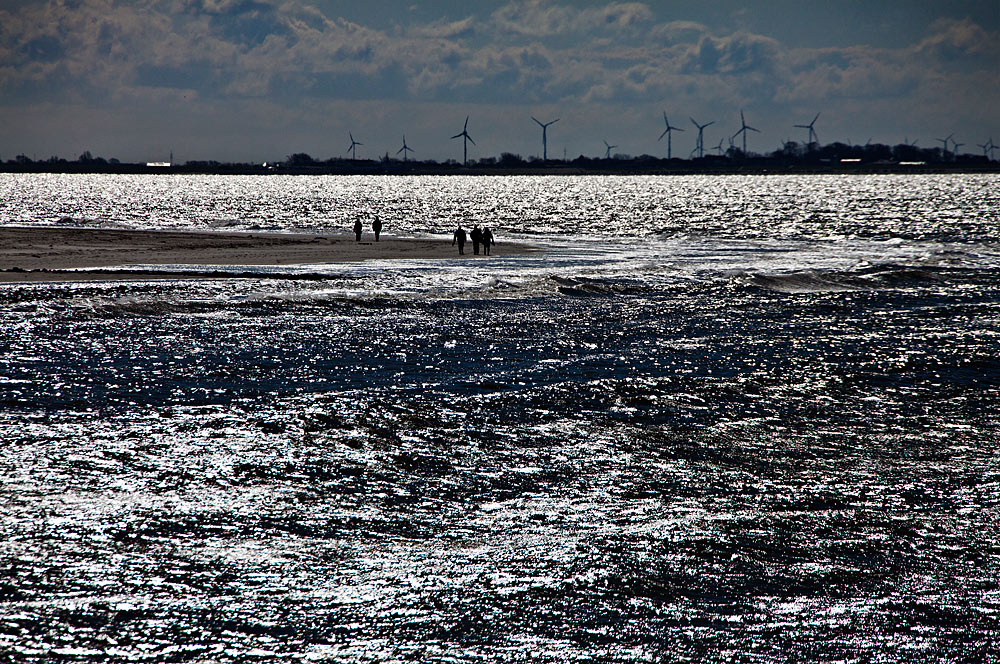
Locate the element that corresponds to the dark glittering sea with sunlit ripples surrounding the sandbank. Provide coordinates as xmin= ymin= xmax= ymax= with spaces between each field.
xmin=0 ymin=174 xmax=1000 ymax=664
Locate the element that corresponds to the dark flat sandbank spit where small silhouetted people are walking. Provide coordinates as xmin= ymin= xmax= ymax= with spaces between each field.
xmin=0 ymin=227 xmax=531 ymax=283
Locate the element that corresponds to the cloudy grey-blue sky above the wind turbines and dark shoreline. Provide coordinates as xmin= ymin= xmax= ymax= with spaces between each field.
xmin=0 ymin=0 xmax=1000 ymax=163
